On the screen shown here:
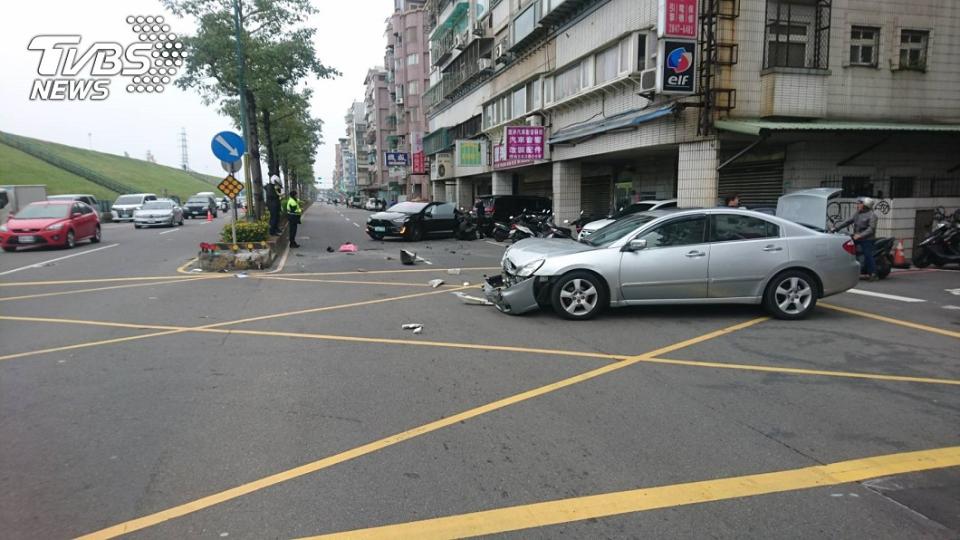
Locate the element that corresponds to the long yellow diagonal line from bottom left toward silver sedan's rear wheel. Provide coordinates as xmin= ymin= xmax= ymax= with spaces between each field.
xmin=80 ymin=317 xmax=766 ymax=540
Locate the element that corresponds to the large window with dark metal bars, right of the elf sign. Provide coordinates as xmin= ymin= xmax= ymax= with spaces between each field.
xmin=764 ymin=0 xmax=831 ymax=69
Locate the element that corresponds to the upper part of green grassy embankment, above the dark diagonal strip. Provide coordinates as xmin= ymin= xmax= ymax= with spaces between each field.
xmin=0 ymin=135 xmax=219 ymax=200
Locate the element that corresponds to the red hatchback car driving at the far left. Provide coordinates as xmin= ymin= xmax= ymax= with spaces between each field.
xmin=0 ymin=201 xmax=100 ymax=251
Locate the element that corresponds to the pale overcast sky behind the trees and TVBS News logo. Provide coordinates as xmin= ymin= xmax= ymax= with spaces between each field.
xmin=0 ymin=0 xmax=393 ymax=189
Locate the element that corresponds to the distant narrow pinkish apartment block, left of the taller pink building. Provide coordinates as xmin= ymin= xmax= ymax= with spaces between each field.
xmin=363 ymin=67 xmax=397 ymax=199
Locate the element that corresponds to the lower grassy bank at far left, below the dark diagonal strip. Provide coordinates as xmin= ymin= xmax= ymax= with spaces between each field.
xmin=0 ymin=144 xmax=119 ymax=201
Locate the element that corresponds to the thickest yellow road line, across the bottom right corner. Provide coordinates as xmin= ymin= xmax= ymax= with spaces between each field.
xmin=311 ymin=446 xmax=960 ymax=540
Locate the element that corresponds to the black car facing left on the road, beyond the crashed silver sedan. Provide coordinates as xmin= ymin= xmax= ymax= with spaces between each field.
xmin=367 ymin=202 xmax=458 ymax=241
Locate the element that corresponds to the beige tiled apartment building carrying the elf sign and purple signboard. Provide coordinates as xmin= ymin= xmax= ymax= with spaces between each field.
xmin=424 ymin=0 xmax=960 ymax=253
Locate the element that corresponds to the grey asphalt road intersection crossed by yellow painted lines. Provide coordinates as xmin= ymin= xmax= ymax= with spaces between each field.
xmin=0 ymin=205 xmax=960 ymax=539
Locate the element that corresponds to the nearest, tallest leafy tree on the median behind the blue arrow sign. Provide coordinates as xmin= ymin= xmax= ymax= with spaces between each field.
xmin=162 ymin=0 xmax=340 ymax=218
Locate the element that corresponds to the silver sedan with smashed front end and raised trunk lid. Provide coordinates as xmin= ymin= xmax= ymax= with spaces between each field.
xmin=484 ymin=205 xmax=860 ymax=319
